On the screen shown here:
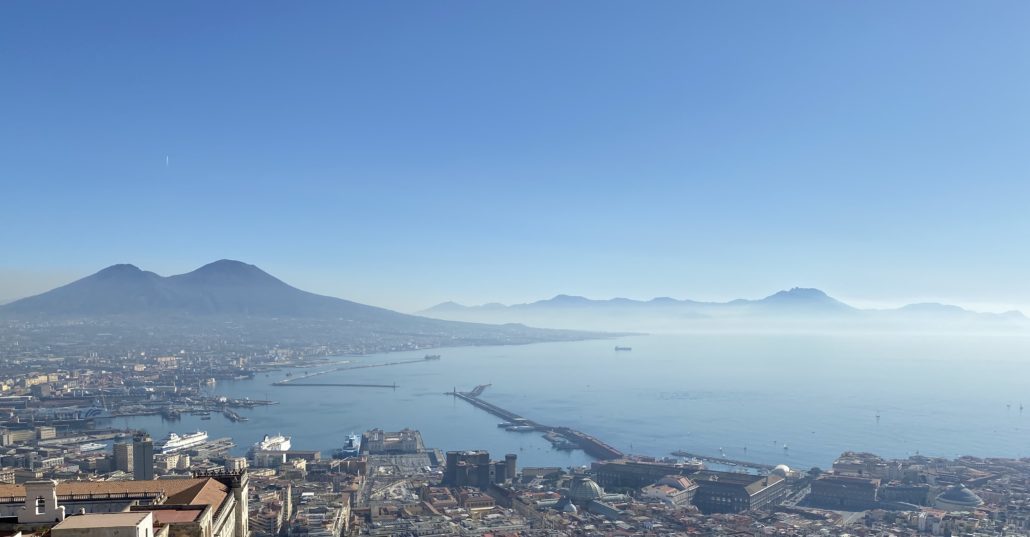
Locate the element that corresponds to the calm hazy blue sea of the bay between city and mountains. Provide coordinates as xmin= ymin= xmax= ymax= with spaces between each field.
xmin=114 ymin=333 xmax=1030 ymax=469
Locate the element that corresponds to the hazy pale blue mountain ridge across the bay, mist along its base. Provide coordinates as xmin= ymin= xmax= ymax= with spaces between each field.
xmin=420 ymin=288 xmax=1026 ymax=331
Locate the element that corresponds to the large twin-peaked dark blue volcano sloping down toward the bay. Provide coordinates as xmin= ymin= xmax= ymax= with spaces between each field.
xmin=0 ymin=260 xmax=604 ymax=351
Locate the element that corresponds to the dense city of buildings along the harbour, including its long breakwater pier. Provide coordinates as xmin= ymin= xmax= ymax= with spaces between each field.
xmin=0 ymin=333 xmax=1030 ymax=537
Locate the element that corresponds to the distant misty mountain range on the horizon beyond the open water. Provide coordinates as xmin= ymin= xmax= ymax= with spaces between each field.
xmin=419 ymin=288 xmax=1026 ymax=330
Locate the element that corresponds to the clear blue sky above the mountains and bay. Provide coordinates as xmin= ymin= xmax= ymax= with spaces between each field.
xmin=0 ymin=0 xmax=1030 ymax=310
